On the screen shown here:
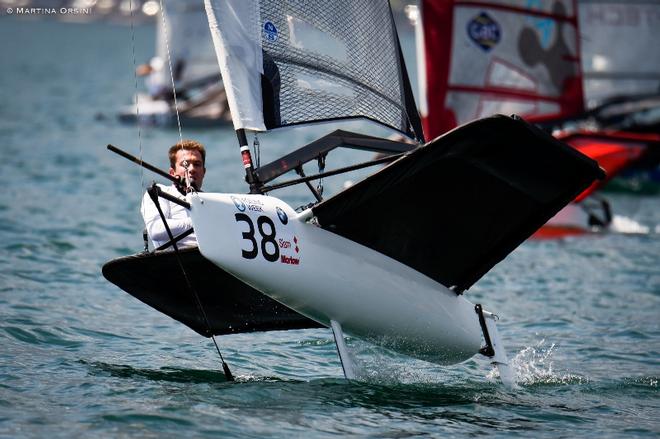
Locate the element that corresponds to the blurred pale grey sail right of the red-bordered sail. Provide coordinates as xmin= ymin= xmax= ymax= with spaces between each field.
xmin=579 ymin=0 xmax=660 ymax=107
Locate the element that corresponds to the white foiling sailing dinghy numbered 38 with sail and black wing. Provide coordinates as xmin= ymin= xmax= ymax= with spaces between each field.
xmin=120 ymin=0 xmax=603 ymax=383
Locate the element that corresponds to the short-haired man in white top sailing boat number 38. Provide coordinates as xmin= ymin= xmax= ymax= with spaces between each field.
xmin=140 ymin=140 xmax=206 ymax=249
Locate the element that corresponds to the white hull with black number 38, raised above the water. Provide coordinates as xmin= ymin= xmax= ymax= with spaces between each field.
xmin=190 ymin=193 xmax=481 ymax=364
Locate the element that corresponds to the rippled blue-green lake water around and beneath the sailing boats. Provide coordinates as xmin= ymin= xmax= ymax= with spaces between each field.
xmin=0 ymin=17 xmax=660 ymax=438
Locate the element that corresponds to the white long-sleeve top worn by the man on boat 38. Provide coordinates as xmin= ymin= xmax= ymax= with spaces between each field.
xmin=140 ymin=184 xmax=197 ymax=250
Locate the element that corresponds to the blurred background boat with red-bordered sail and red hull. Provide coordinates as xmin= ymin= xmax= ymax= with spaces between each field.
xmin=417 ymin=0 xmax=660 ymax=236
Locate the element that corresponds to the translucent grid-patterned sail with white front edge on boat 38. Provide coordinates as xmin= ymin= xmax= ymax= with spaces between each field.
xmin=206 ymin=0 xmax=422 ymax=139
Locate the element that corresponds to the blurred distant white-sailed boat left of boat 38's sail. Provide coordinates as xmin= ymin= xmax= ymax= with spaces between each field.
xmin=118 ymin=0 xmax=230 ymax=127
